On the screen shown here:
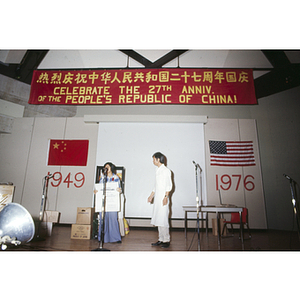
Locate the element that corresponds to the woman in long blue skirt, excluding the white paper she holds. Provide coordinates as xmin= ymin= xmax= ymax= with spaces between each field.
xmin=95 ymin=162 xmax=122 ymax=243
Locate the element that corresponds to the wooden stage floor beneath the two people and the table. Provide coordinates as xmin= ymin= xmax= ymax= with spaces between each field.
xmin=6 ymin=225 xmax=300 ymax=251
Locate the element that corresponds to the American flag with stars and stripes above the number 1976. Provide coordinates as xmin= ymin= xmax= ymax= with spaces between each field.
xmin=209 ymin=141 xmax=255 ymax=167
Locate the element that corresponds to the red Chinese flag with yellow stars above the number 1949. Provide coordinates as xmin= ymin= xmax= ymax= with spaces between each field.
xmin=48 ymin=140 xmax=89 ymax=166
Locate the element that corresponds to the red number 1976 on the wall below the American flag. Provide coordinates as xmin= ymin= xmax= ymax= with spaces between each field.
xmin=216 ymin=174 xmax=255 ymax=191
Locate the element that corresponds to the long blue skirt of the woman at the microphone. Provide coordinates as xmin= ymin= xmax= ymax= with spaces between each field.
xmin=98 ymin=211 xmax=121 ymax=243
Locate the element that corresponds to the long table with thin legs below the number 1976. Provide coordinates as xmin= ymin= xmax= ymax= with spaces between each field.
xmin=182 ymin=205 xmax=244 ymax=250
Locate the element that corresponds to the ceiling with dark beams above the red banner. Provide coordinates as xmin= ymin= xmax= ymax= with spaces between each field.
xmin=0 ymin=49 xmax=300 ymax=99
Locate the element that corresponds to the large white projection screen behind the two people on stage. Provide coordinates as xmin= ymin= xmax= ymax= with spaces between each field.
xmin=96 ymin=122 xmax=206 ymax=218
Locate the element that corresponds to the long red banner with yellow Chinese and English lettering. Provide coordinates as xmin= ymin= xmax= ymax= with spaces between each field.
xmin=29 ymin=69 xmax=257 ymax=105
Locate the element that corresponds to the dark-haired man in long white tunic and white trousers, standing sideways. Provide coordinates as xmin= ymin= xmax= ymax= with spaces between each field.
xmin=148 ymin=152 xmax=173 ymax=248
